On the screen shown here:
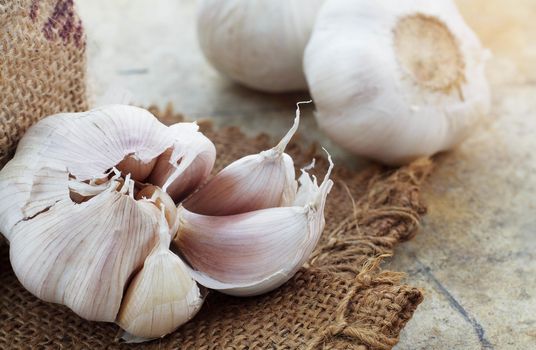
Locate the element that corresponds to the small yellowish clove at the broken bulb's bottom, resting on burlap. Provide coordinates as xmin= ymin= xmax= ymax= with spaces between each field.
xmin=116 ymin=211 xmax=203 ymax=340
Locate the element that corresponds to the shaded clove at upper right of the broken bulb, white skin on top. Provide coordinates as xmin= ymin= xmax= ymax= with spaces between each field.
xmin=149 ymin=123 xmax=216 ymax=202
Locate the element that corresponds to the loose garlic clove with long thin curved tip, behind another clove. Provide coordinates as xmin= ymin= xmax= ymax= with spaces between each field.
xmin=183 ymin=102 xmax=310 ymax=216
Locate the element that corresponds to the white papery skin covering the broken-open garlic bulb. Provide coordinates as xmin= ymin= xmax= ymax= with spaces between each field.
xmin=0 ymin=105 xmax=215 ymax=322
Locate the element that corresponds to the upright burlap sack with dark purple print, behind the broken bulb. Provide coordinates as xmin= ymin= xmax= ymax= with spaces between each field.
xmin=0 ymin=0 xmax=87 ymax=168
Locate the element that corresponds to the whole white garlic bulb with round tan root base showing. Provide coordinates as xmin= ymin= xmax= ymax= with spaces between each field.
xmin=304 ymin=0 xmax=490 ymax=164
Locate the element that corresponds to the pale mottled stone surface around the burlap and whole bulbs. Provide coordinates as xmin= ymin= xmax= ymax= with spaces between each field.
xmin=78 ymin=0 xmax=536 ymax=350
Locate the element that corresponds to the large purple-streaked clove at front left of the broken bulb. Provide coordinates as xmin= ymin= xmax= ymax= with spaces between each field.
xmin=10 ymin=179 xmax=158 ymax=322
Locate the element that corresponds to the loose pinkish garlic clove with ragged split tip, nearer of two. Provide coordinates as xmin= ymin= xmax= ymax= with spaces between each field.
xmin=174 ymin=157 xmax=333 ymax=296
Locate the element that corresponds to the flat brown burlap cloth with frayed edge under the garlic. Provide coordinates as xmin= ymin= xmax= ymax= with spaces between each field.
xmin=0 ymin=107 xmax=431 ymax=350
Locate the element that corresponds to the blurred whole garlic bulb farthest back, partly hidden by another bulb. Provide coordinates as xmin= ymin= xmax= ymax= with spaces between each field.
xmin=197 ymin=0 xmax=324 ymax=92
